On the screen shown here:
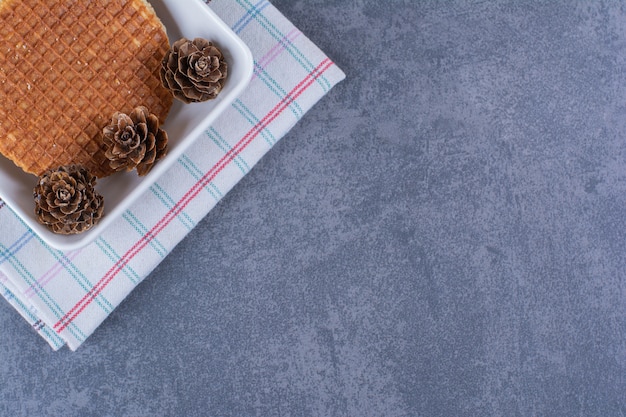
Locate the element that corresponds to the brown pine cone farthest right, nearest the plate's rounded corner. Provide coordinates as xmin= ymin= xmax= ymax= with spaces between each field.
xmin=161 ymin=38 xmax=228 ymax=103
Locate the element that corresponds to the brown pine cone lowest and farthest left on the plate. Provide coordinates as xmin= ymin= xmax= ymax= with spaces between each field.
xmin=33 ymin=165 xmax=104 ymax=235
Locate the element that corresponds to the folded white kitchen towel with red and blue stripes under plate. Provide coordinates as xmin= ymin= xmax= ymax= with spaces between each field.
xmin=0 ymin=0 xmax=344 ymax=350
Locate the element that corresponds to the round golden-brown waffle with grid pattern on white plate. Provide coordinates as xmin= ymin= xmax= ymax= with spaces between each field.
xmin=0 ymin=0 xmax=172 ymax=177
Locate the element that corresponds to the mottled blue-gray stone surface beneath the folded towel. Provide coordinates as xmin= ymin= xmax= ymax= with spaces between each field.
xmin=0 ymin=0 xmax=626 ymax=417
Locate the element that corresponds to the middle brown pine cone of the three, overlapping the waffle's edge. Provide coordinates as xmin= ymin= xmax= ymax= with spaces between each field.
xmin=102 ymin=106 xmax=167 ymax=176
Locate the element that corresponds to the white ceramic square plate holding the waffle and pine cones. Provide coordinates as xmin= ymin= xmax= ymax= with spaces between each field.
xmin=0 ymin=0 xmax=253 ymax=251
